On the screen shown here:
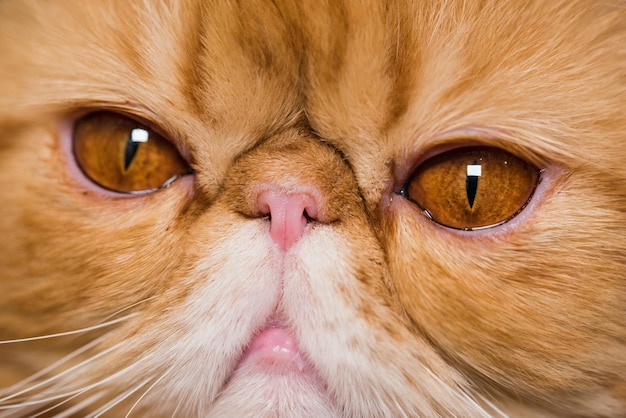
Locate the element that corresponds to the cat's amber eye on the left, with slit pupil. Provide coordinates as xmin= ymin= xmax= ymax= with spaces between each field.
xmin=74 ymin=112 xmax=191 ymax=194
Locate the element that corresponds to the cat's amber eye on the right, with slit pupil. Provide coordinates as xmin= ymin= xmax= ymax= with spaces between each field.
xmin=403 ymin=147 xmax=540 ymax=230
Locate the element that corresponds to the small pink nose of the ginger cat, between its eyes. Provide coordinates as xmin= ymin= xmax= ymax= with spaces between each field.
xmin=257 ymin=190 xmax=318 ymax=251
